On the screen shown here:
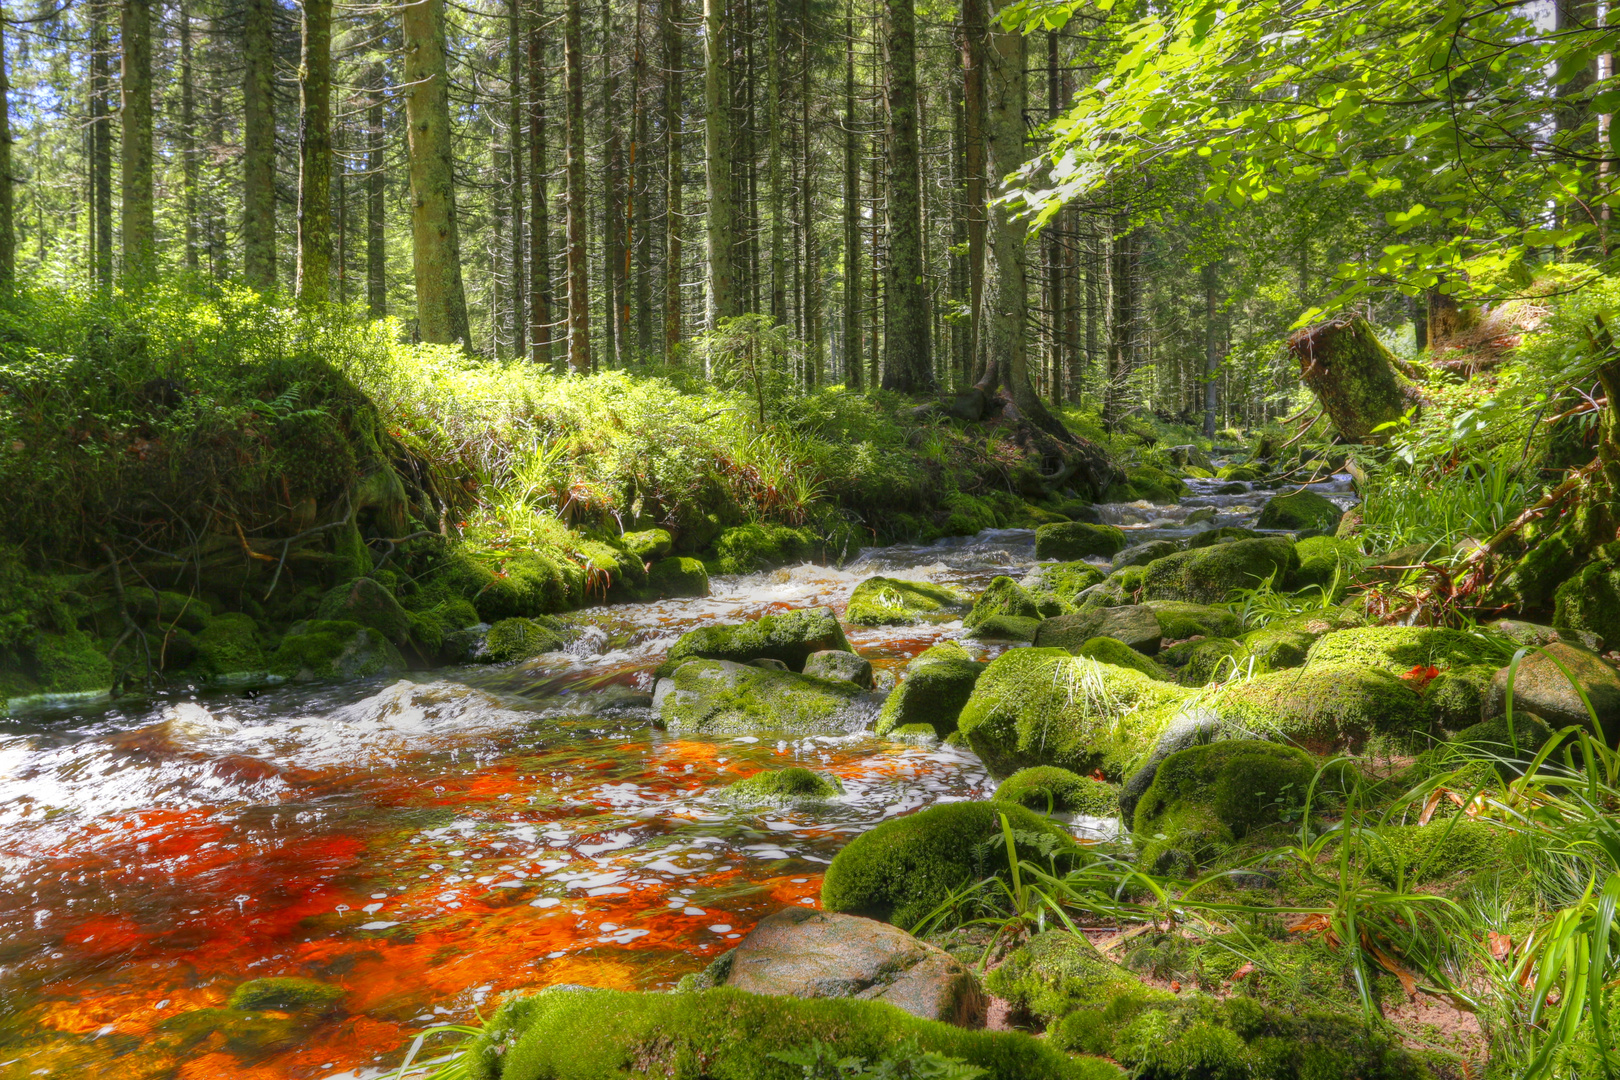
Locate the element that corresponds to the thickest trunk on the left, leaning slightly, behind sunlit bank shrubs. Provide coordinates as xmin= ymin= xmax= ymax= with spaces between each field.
xmin=403 ymin=0 xmax=471 ymax=345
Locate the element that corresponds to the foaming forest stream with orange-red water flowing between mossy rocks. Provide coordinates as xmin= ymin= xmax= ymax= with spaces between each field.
xmin=0 ymin=478 xmax=1349 ymax=1080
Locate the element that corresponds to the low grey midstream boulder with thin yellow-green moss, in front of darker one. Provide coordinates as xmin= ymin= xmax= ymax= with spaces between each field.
xmin=653 ymin=659 xmax=876 ymax=735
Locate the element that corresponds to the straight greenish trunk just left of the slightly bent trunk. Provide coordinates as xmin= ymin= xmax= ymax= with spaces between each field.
xmin=241 ymin=0 xmax=275 ymax=290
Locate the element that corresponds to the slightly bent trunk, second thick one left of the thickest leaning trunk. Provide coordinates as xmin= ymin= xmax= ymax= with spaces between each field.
xmin=293 ymin=0 xmax=332 ymax=304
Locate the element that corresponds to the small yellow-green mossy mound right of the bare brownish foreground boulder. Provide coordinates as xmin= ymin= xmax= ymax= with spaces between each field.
xmin=985 ymin=929 xmax=1144 ymax=1027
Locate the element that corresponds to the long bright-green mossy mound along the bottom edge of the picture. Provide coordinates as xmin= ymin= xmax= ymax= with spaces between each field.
xmin=467 ymin=988 xmax=1119 ymax=1080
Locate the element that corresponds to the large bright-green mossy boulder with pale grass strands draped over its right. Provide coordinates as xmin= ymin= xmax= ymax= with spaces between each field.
xmin=957 ymin=648 xmax=1187 ymax=779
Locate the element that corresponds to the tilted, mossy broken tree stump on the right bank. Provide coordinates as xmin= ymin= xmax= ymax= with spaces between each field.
xmin=1288 ymin=317 xmax=1422 ymax=442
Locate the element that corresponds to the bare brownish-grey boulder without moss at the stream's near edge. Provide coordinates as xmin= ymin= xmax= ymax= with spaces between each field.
xmin=714 ymin=907 xmax=985 ymax=1028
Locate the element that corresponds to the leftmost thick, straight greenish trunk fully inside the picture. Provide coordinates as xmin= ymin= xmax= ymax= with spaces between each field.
xmin=118 ymin=0 xmax=157 ymax=288
